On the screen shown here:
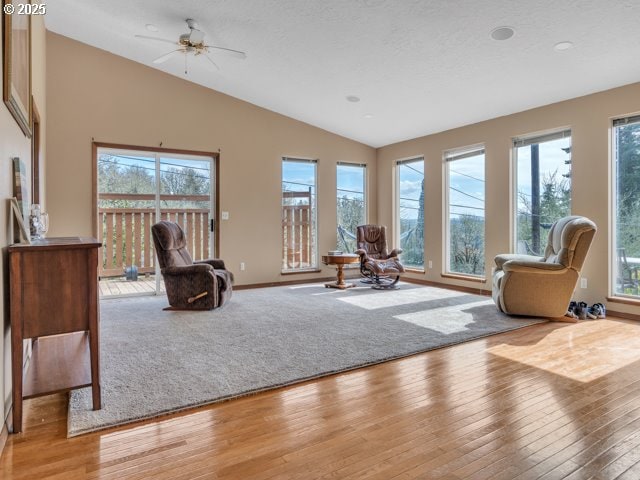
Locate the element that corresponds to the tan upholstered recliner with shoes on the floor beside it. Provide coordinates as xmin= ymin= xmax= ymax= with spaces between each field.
xmin=493 ymin=216 xmax=596 ymax=318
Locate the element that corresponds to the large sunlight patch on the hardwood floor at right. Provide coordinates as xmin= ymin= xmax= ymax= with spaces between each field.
xmin=489 ymin=320 xmax=640 ymax=382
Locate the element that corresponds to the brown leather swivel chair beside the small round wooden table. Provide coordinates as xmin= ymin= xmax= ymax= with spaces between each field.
xmin=355 ymin=225 xmax=404 ymax=289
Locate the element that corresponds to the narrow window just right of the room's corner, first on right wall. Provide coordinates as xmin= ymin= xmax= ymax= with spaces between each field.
xmin=396 ymin=157 xmax=424 ymax=269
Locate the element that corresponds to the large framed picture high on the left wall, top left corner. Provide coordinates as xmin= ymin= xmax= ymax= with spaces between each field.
xmin=2 ymin=0 xmax=32 ymax=137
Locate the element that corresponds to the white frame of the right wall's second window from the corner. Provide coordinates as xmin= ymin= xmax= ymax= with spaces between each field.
xmin=442 ymin=143 xmax=487 ymax=280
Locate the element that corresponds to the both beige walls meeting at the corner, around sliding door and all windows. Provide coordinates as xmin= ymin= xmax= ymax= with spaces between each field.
xmin=46 ymin=33 xmax=640 ymax=313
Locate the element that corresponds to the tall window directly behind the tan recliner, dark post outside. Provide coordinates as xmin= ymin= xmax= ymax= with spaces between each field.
xmin=513 ymin=130 xmax=571 ymax=255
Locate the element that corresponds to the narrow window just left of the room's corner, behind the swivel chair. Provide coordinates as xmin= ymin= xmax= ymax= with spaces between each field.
xmin=336 ymin=163 xmax=367 ymax=252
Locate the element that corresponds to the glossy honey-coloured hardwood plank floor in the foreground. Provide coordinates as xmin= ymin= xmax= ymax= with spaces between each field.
xmin=0 ymin=320 xmax=640 ymax=480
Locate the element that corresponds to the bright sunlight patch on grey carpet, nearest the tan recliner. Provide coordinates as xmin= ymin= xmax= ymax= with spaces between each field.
xmin=393 ymin=300 xmax=493 ymax=334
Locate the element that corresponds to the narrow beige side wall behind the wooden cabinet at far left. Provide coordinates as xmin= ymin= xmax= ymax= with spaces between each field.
xmin=0 ymin=16 xmax=46 ymax=420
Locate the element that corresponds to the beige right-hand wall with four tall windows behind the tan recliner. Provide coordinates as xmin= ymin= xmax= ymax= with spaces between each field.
xmin=377 ymin=83 xmax=640 ymax=314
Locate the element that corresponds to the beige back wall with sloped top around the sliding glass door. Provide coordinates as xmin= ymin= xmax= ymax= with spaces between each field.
xmin=46 ymin=32 xmax=377 ymax=285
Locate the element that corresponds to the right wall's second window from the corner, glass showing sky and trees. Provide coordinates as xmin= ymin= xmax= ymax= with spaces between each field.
xmin=444 ymin=147 xmax=485 ymax=276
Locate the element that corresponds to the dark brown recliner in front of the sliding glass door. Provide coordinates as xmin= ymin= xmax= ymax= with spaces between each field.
xmin=151 ymin=220 xmax=233 ymax=310
